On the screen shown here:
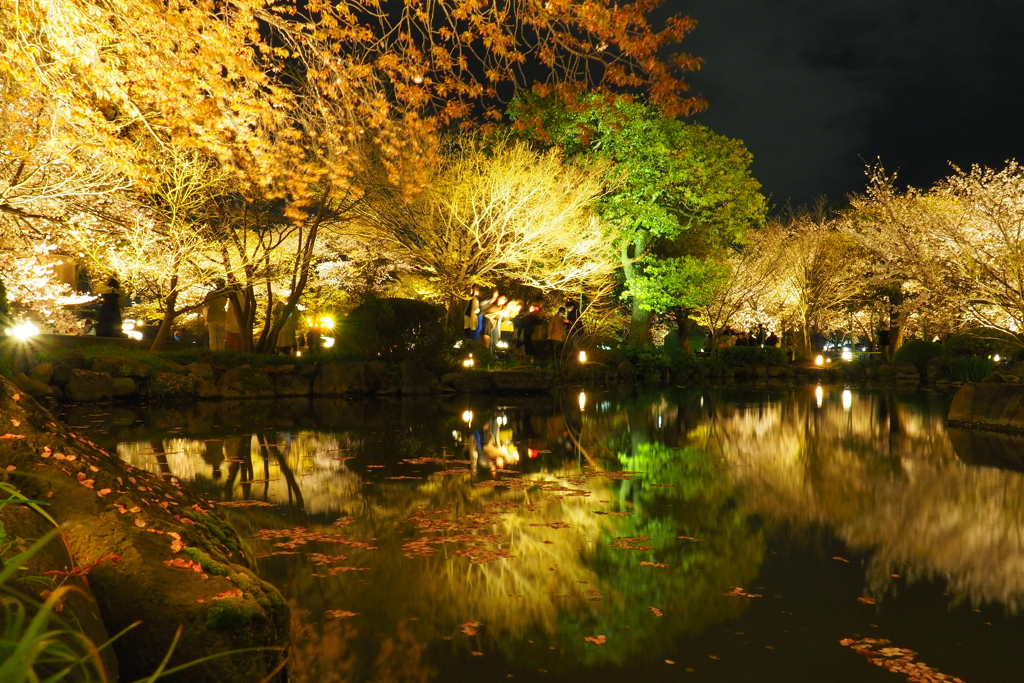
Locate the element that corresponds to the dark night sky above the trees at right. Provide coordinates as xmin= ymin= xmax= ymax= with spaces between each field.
xmin=667 ymin=0 xmax=1024 ymax=208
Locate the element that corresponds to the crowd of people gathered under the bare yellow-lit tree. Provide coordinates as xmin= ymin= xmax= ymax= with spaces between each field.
xmin=463 ymin=287 xmax=580 ymax=358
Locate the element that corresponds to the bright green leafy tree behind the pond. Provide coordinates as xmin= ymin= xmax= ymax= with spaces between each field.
xmin=509 ymin=93 xmax=766 ymax=344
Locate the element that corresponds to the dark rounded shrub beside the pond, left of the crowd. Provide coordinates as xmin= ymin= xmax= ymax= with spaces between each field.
xmin=339 ymin=299 xmax=444 ymax=364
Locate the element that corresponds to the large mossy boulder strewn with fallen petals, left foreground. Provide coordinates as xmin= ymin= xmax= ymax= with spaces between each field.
xmin=0 ymin=378 xmax=289 ymax=683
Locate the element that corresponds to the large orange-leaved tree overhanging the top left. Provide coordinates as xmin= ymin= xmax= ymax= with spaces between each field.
xmin=0 ymin=0 xmax=702 ymax=344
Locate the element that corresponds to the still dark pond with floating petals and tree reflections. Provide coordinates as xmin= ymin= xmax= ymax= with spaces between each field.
xmin=65 ymin=387 xmax=1024 ymax=683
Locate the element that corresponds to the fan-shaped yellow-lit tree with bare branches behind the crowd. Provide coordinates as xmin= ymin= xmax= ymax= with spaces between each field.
xmin=350 ymin=138 xmax=614 ymax=321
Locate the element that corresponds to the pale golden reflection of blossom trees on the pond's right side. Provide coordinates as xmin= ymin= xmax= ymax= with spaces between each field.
xmin=702 ymin=391 xmax=1024 ymax=612
